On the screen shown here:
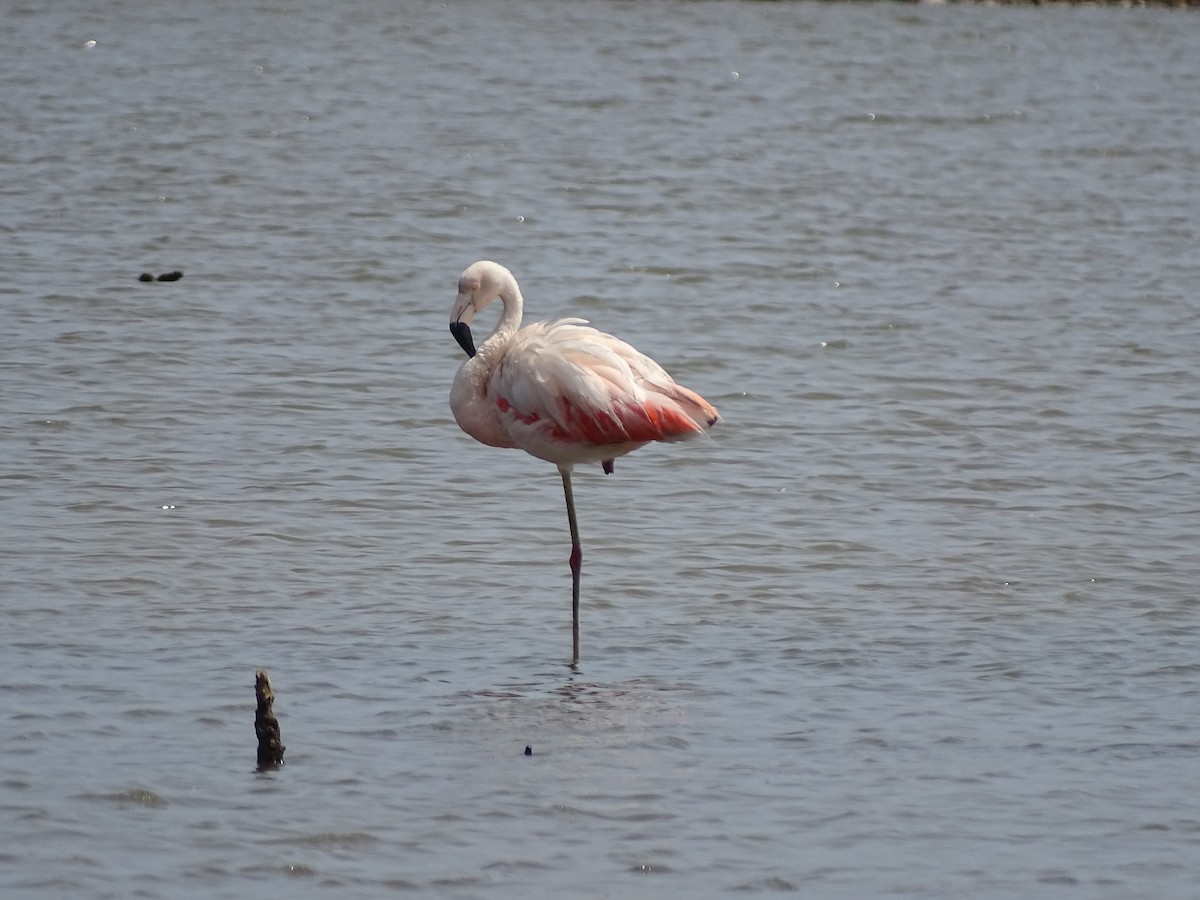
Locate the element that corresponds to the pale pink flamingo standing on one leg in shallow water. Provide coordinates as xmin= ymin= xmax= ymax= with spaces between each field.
xmin=450 ymin=259 xmax=720 ymax=664
